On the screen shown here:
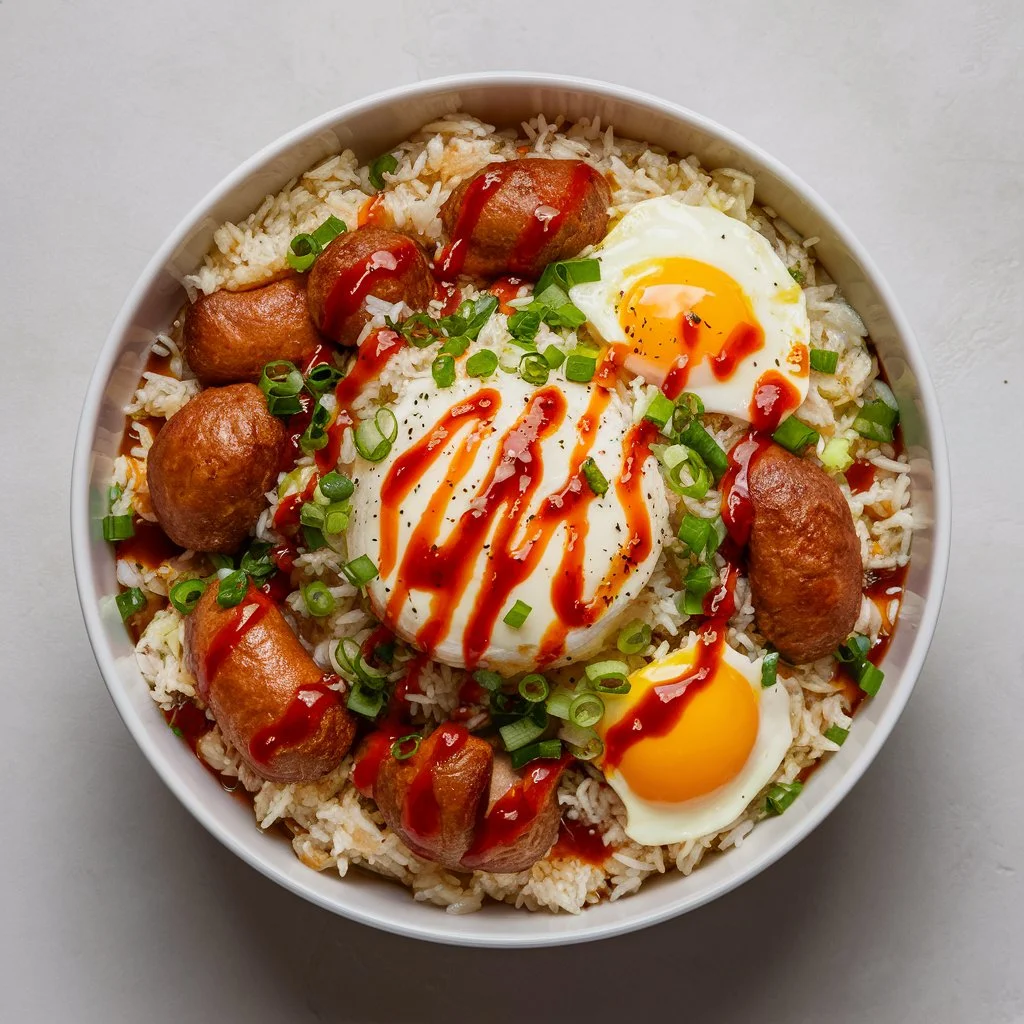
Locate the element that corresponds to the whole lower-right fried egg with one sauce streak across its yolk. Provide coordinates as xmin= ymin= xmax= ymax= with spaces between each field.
xmin=597 ymin=637 xmax=793 ymax=846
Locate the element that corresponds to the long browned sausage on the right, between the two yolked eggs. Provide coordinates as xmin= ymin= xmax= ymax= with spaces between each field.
xmin=750 ymin=444 xmax=862 ymax=665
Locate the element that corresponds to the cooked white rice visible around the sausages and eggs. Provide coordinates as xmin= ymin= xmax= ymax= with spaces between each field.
xmin=114 ymin=115 xmax=914 ymax=913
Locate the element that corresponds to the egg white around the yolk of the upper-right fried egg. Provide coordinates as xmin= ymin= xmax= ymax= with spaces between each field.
xmin=569 ymin=196 xmax=810 ymax=421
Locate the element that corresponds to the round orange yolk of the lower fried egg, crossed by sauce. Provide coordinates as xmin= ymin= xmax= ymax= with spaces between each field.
xmin=598 ymin=651 xmax=760 ymax=804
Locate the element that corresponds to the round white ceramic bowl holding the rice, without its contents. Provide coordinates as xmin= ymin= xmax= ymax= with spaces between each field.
xmin=71 ymin=74 xmax=950 ymax=946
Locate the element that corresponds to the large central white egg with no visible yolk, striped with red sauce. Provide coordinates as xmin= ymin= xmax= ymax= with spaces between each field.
xmin=347 ymin=372 xmax=668 ymax=675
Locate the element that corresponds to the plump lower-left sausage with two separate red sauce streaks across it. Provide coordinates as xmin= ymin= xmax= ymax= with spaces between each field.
xmin=185 ymin=583 xmax=355 ymax=782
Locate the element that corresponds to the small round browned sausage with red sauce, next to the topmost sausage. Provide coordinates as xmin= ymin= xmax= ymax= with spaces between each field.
xmin=307 ymin=224 xmax=434 ymax=345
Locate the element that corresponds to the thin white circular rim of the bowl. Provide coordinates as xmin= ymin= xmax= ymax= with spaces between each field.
xmin=70 ymin=71 xmax=951 ymax=948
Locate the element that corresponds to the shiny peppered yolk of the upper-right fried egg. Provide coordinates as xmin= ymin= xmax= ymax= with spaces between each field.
xmin=618 ymin=257 xmax=764 ymax=390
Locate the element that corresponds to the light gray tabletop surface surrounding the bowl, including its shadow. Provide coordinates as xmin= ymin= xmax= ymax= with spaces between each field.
xmin=0 ymin=0 xmax=1024 ymax=1024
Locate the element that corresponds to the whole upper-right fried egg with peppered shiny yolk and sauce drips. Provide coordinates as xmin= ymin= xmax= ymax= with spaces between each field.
xmin=569 ymin=196 xmax=810 ymax=428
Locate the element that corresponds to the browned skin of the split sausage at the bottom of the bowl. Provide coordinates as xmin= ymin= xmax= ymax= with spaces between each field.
xmin=374 ymin=724 xmax=561 ymax=871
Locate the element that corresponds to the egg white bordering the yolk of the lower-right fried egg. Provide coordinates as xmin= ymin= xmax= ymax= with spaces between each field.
xmin=605 ymin=637 xmax=793 ymax=846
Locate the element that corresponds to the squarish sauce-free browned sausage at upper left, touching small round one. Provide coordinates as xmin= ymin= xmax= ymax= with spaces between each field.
xmin=181 ymin=278 xmax=319 ymax=387
